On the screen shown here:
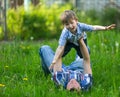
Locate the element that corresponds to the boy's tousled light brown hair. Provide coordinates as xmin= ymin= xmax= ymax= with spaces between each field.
xmin=60 ymin=10 xmax=77 ymax=24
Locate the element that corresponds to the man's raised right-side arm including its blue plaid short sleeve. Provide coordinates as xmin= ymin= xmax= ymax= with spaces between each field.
xmin=79 ymin=38 xmax=92 ymax=91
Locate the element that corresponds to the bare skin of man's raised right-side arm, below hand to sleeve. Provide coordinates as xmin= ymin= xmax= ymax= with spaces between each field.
xmin=79 ymin=38 xmax=92 ymax=74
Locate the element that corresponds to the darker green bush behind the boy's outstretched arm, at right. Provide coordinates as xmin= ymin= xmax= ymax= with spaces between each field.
xmin=75 ymin=7 xmax=120 ymax=28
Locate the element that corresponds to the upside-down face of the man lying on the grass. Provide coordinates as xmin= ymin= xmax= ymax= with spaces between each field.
xmin=67 ymin=79 xmax=81 ymax=92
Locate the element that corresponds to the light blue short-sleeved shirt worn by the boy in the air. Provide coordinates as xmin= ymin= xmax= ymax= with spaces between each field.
xmin=59 ymin=22 xmax=93 ymax=46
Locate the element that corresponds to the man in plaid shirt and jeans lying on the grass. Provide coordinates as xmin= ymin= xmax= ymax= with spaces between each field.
xmin=40 ymin=24 xmax=115 ymax=91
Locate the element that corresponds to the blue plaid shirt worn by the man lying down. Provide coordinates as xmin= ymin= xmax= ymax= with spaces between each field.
xmin=52 ymin=71 xmax=93 ymax=91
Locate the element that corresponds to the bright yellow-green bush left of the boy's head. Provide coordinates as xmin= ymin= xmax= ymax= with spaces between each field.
xmin=7 ymin=4 xmax=71 ymax=39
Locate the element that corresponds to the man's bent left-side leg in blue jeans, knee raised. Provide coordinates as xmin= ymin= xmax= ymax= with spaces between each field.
xmin=39 ymin=45 xmax=55 ymax=74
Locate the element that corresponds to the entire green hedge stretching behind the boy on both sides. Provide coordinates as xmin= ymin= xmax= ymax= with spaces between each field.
xmin=4 ymin=4 xmax=120 ymax=40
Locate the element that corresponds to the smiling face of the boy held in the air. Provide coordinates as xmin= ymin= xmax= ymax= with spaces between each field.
xmin=64 ymin=19 xmax=78 ymax=34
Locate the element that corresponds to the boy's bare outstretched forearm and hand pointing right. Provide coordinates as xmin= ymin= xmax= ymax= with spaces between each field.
xmin=93 ymin=24 xmax=116 ymax=30
